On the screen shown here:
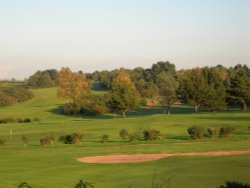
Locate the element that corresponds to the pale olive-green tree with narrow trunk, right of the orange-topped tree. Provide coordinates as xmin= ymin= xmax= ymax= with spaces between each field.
xmin=156 ymin=72 xmax=179 ymax=114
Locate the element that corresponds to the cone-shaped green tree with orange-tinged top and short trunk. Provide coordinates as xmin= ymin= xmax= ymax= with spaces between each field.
xmin=110 ymin=72 xmax=139 ymax=118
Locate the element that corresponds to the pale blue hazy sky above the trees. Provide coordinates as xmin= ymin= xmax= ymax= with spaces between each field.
xmin=0 ymin=0 xmax=250 ymax=79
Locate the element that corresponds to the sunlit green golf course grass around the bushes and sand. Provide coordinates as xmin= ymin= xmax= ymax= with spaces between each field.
xmin=0 ymin=88 xmax=250 ymax=188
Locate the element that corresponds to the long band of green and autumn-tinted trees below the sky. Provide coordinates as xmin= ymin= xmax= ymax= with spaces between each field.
xmin=24 ymin=61 xmax=250 ymax=117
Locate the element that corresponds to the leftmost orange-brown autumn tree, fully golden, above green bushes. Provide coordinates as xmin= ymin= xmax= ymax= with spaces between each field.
xmin=57 ymin=68 xmax=90 ymax=101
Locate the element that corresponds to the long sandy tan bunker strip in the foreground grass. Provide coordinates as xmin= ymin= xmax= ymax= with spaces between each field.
xmin=77 ymin=150 xmax=250 ymax=163
